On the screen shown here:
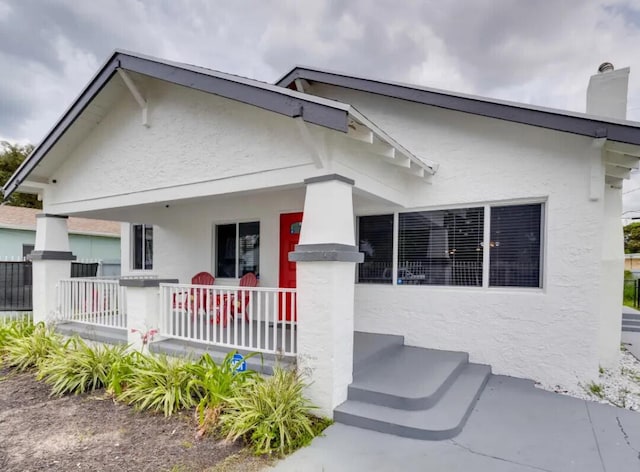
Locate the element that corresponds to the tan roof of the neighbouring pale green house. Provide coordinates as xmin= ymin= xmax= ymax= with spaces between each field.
xmin=0 ymin=205 xmax=120 ymax=238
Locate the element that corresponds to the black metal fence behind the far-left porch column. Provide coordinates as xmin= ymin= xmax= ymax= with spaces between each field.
xmin=0 ymin=261 xmax=98 ymax=311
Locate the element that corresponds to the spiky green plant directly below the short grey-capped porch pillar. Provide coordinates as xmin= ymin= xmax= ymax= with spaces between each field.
xmin=117 ymin=354 xmax=200 ymax=416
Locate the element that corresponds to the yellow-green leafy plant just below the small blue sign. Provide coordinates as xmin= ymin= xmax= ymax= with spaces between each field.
xmin=190 ymin=351 xmax=257 ymax=437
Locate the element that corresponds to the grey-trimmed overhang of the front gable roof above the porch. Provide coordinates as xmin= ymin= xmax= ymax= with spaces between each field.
xmin=2 ymin=51 xmax=437 ymax=199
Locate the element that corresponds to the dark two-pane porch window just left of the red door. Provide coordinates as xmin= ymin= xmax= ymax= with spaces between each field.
xmin=216 ymin=221 xmax=260 ymax=278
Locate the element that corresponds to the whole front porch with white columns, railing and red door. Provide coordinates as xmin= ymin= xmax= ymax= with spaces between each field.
xmin=32 ymin=175 xmax=364 ymax=416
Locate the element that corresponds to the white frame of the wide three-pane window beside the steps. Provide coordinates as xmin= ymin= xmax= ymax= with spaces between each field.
xmin=355 ymin=198 xmax=548 ymax=291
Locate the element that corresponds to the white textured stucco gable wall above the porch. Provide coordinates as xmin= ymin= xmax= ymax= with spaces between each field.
xmin=45 ymin=79 xmax=312 ymax=209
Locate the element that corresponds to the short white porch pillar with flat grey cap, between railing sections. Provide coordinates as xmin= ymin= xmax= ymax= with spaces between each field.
xmin=119 ymin=277 xmax=178 ymax=351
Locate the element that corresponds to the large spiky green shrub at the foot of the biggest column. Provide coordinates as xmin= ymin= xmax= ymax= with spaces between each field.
xmin=220 ymin=368 xmax=322 ymax=455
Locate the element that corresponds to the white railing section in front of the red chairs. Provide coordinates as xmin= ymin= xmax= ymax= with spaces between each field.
xmin=159 ymin=284 xmax=297 ymax=356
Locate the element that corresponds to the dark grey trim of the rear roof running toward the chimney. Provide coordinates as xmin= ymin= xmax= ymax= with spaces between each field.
xmin=276 ymin=67 xmax=640 ymax=145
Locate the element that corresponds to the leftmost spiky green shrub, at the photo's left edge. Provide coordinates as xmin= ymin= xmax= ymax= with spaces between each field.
xmin=4 ymin=323 xmax=63 ymax=371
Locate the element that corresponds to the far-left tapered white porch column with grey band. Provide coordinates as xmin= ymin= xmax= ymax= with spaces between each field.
xmin=28 ymin=213 xmax=75 ymax=323
